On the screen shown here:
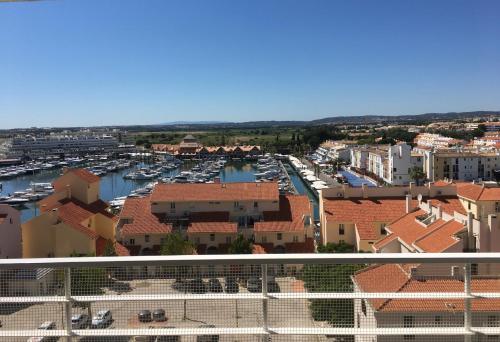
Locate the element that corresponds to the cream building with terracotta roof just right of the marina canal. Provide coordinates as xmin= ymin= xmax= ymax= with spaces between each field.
xmin=319 ymin=184 xmax=460 ymax=251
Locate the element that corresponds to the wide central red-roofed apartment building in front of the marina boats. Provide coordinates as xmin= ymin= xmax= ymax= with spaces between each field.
xmin=118 ymin=182 xmax=314 ymax=254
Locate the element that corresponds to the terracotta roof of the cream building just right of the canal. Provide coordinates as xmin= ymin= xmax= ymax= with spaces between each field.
xmin=323 ymin=197 xmax=418 ymax=240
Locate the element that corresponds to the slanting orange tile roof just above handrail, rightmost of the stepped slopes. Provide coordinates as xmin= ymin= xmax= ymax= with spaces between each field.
xmin=415 ymin=220 xmax=465 ymax=253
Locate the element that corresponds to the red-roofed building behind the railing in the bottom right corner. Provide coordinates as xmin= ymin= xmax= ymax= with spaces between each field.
xmin=352 ymin=264 xmax=500 ymax=342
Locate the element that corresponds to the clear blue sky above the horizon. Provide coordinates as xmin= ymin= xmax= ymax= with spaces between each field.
xmin=0 ymin=0 xmax=500 ymax=128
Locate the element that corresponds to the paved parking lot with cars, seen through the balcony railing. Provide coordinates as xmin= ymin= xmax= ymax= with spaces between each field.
xmin=0 ymin=277 xmax=328 ymax=341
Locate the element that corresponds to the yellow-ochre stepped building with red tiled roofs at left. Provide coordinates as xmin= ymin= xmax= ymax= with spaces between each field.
xmin=22 ymin=169 xmax=128 ymax=258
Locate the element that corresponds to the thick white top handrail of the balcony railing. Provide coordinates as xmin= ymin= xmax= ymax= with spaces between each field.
xmin=0 ymin=253 xmax=500 ymax=269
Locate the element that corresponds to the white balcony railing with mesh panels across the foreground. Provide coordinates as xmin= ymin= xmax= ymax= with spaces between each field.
xmin=0 ymin=253 xmax=500 ymax=341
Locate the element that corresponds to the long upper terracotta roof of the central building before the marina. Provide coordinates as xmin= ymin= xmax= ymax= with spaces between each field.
xmin=151 ymin=182 xmax=279 ymax=202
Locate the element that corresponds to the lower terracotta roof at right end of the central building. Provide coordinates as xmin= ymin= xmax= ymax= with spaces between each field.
xmin=254 ymin=195 xmax=312 ymax=232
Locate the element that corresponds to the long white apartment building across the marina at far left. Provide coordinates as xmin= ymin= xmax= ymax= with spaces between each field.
xmin=0 ymin=135 xmax=119 ymax=158
